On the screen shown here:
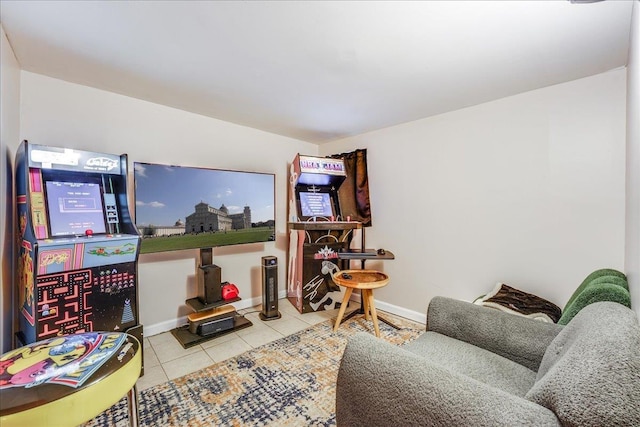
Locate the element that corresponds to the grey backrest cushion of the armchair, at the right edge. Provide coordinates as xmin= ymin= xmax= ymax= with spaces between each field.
xmin=525 ymin=302 xmax=640 ymax=426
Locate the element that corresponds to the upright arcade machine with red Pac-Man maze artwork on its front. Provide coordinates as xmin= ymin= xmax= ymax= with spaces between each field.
xmin=16 ymin=141 xmax=142 ymax=345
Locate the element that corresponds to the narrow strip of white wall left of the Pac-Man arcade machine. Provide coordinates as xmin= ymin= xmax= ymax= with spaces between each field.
xmin=0 ymin=26 xmax=20 ymax=353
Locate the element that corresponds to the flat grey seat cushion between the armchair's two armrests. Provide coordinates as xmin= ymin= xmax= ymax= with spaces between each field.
xmin=404 ymin=332 xmax=536 ymax=397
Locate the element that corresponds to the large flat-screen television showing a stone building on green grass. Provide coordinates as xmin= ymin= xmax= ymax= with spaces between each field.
xmin=133 ymin=162 xmax=275 ymax=253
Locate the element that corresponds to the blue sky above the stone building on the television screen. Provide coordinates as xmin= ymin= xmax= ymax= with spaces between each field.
xmin=134 ymin=162 xmax=275 ymax=226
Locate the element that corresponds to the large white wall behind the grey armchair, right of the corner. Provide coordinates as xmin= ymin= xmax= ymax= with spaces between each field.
xmin=320 ymin=70 xmax=626 ymax=313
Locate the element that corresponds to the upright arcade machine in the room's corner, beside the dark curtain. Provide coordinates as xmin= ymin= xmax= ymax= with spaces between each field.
xmin=287 ymin=154 xmax=362 ymax=313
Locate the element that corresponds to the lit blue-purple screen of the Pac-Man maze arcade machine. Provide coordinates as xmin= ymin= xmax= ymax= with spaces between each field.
xmin=45 ymin=181 xmax=106 ymax=237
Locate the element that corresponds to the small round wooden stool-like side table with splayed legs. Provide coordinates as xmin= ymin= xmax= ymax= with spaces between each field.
xmin=333 ymin=270 xmax=389 ymax=338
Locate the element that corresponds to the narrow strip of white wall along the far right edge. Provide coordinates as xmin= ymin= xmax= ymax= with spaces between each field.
xmin=625 ymin=1 xmax=640 ymax=315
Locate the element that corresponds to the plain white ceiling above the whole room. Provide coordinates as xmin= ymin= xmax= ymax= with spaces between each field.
xmin=0 ymin=0 xmax=633 ymax=143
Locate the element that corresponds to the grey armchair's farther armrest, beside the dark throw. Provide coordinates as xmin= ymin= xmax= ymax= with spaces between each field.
xmin=427 ymin=297 xmax=562 ymax=372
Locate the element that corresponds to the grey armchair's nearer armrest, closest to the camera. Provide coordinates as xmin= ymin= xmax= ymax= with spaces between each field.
xmin=336 ymin=333 xmax=559 ymax=427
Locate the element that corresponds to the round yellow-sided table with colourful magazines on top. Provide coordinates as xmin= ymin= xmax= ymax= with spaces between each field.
xmin=0 ymin=332 xmax=142 ymax=427
